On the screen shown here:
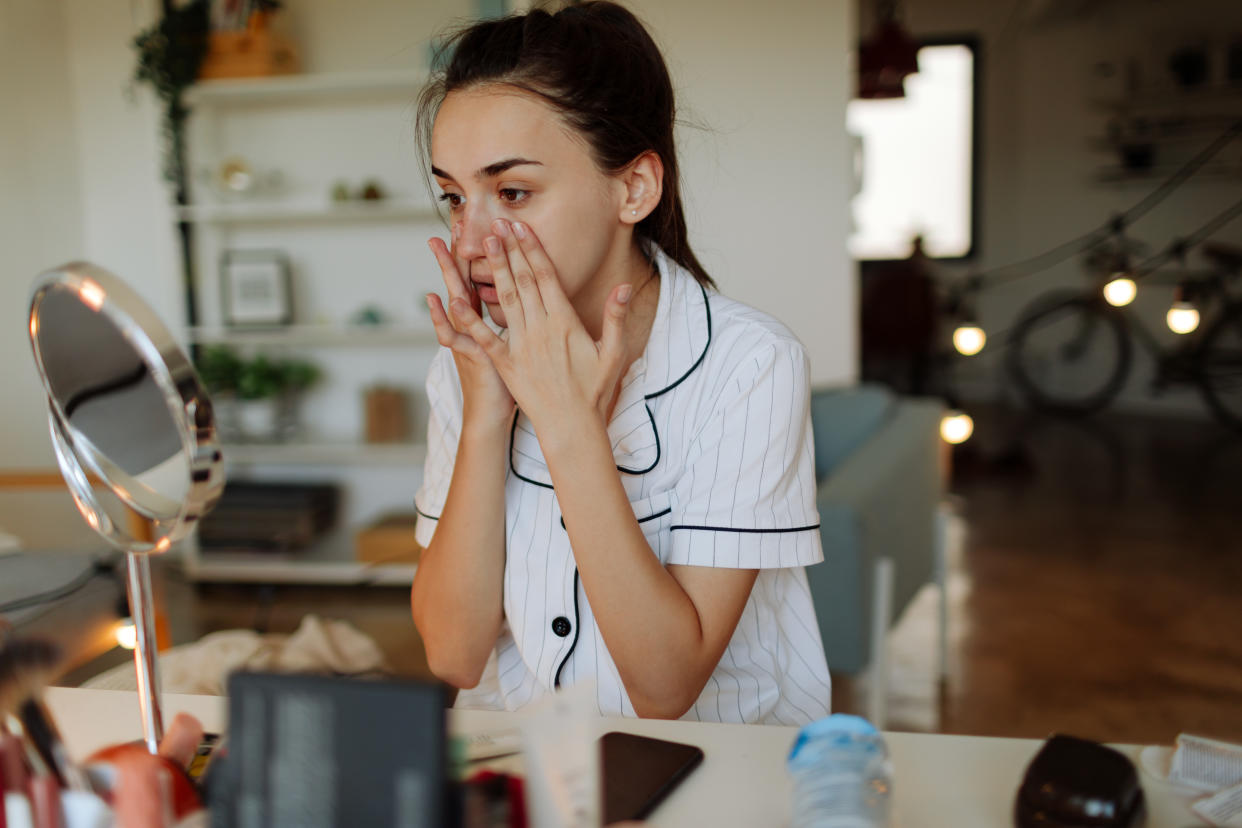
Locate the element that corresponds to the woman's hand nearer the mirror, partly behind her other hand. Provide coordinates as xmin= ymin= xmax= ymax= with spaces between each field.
xmin=427 ymin=227 xmax=515 ymax=426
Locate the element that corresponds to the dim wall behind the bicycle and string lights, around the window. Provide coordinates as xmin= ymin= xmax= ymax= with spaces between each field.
xmin=904 ymin=0 xmax=1242 ymax=415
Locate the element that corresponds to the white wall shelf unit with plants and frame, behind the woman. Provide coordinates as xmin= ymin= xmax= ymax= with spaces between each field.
xmin=176 ymin=71 xmax=446 ymax=585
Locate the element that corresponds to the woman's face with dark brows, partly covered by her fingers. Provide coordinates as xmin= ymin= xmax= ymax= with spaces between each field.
xmin=431 ymin=86 xmax=626 ymax=325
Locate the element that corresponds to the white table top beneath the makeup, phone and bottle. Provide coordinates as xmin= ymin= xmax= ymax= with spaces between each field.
xmin=46 ymin=688 xmax=1207 ymax=828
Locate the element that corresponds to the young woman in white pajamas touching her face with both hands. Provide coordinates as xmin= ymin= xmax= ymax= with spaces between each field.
xmin=411 ymin=2 xmax=830 ymax=724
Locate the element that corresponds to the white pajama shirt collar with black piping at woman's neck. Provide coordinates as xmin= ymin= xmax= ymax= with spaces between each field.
xmin=509 ymin=245 xmax=712 ymax=488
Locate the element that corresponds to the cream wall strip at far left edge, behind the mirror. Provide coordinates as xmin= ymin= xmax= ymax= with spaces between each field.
xmin=0 ymin=1 xmax=82 ymax=468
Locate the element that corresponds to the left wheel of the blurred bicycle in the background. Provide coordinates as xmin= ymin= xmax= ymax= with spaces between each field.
xmin=1006 ymin=293 xmax=1133 ymax=415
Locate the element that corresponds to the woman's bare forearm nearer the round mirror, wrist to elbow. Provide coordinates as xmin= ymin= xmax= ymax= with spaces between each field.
xmin=411 ymin=423 xmax=508 ymax=688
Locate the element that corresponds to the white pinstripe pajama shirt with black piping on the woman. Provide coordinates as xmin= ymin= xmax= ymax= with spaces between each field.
xmin=415 ymin=245 xmax=831 ymax=725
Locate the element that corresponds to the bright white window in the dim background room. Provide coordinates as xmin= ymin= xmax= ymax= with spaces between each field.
xmin=846 ymin=40 xmax=976 ymax=261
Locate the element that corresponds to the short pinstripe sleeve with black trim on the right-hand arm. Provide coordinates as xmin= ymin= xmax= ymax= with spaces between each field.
xmin=666 ymin=340 xmax=823 ymax=569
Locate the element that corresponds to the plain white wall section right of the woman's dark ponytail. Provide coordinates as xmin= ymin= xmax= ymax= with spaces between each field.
xmin=630 ymin=0 xmax=858 ymax=385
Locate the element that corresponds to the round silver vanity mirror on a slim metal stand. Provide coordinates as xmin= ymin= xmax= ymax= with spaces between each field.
xmin=30 ymin=262 xmax=225 ymax=752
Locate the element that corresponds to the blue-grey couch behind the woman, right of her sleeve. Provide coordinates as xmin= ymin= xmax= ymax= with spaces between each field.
xmin=806 ymin=385 xmax=944 ymax=724
